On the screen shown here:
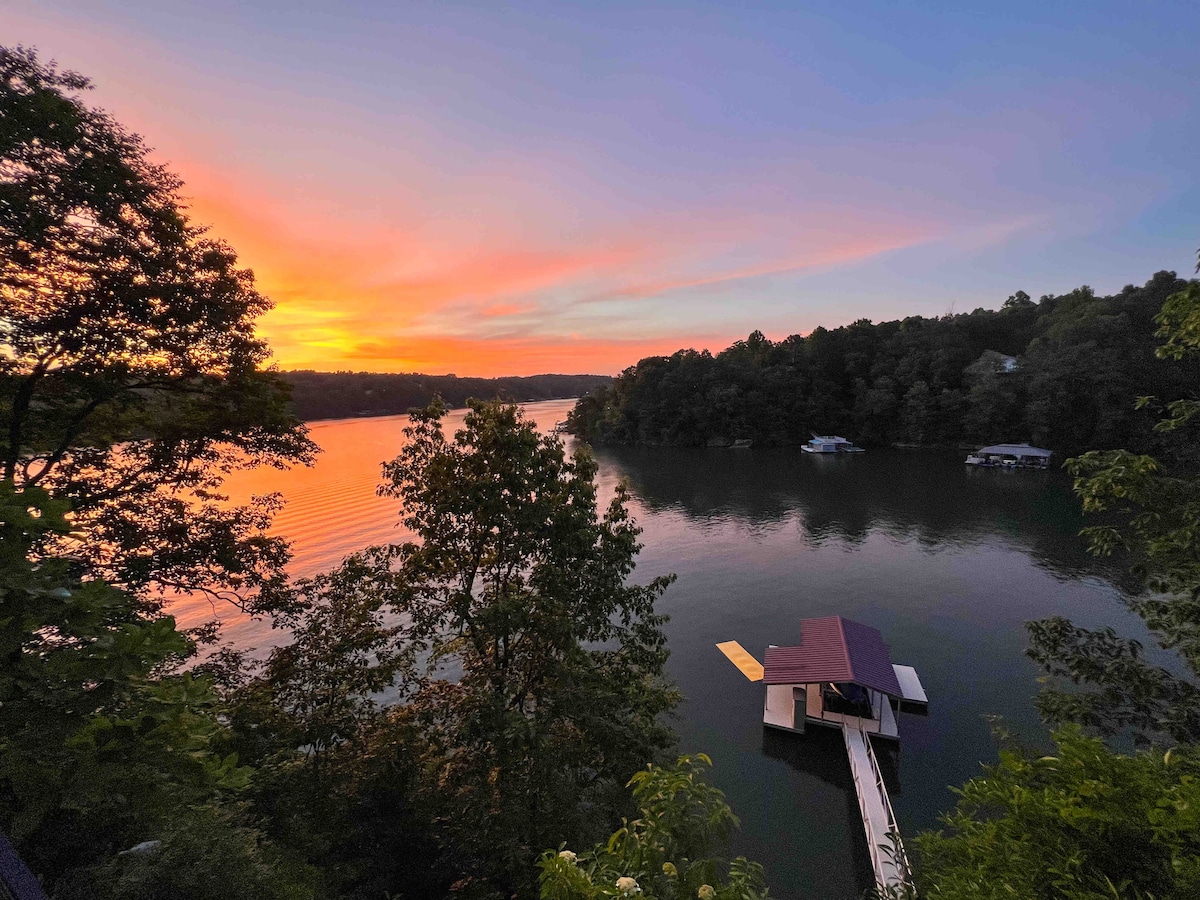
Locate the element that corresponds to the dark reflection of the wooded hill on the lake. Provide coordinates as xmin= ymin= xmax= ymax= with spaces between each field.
xmin=596 ymin=448 xmax=1126 ymax=588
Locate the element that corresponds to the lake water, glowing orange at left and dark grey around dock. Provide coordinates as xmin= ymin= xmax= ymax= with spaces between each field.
xmin=201 ymin=401 xmax=1145 ymax=900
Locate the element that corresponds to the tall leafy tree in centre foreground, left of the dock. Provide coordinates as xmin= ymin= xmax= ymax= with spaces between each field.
xmin=380 ymin=401 xmax=676 ymax=895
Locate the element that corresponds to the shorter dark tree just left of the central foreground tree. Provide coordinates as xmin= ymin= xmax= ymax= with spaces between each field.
xmin=214 ymin=550 xmax=439 ymax=900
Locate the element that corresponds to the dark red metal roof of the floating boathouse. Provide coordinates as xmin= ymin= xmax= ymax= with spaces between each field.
xmin=762 ymin=616 xmax=904 ymax=697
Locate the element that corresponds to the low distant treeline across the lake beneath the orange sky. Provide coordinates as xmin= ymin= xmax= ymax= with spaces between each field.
xmin=282 ymin=371 xmax=612 ymax=421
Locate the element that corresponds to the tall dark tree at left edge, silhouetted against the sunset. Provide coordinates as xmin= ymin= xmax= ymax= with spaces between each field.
xmin=0 ymin=47 xmax=313 ymax=602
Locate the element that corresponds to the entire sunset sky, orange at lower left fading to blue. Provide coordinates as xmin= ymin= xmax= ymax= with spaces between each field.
xmin=9 ymin=0 xmax=1200 ymax=376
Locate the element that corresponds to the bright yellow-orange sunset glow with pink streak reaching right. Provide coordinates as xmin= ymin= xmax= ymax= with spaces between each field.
xmin=174 ymin=161 xmax=928 ymax=376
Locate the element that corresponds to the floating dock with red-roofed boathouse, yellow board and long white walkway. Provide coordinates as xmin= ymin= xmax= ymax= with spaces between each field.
xmin=718 ymin=616 xmax=929 ymax=889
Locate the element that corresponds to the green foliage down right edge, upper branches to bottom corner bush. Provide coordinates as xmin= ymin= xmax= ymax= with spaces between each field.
xmin=917 ymin=252 xmax=1200 ymax=900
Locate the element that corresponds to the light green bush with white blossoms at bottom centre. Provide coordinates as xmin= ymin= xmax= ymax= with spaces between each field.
xmin=538 ymin=754 xmax=767 ymax=900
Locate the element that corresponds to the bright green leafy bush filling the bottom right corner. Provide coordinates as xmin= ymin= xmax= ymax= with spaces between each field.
xmin=916 ymin=728 xmax=1200 ymax=900
